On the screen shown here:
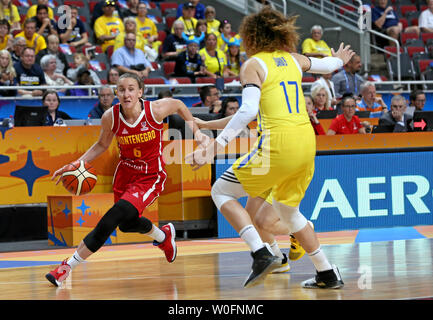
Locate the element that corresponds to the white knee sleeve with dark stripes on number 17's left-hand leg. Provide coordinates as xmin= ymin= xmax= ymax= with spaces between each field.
xmin=211 ymin=168 xmax=248 ymax=210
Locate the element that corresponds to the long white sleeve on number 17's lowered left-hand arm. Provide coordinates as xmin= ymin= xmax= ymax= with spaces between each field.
xmin=216 ymin=86 xmax=261 ymax=147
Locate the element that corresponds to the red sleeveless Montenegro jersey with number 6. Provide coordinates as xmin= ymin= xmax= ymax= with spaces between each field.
xmin=111 ymin=100 xmax=164 ymax=174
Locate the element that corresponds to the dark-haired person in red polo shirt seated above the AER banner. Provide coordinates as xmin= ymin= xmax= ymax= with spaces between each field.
xmin=326 ymin=96 xmax=367 ymax=136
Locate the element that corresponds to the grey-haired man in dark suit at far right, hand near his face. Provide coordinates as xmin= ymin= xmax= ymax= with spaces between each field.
xmin=379 ymin=95 xmax=412 ymax=132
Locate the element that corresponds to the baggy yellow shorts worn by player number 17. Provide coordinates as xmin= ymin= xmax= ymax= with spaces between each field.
xmin=233 ymin=125 xmax=316 ymax=207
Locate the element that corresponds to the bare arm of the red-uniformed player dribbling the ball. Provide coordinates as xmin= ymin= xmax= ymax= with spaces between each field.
xmin=51 ymin=109 xmax=114 ymax=184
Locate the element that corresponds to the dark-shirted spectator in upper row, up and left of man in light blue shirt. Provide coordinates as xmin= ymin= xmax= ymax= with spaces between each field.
xmin=57 ymin=6 xmax=92 ymax=49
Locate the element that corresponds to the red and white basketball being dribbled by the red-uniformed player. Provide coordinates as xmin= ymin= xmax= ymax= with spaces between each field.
xmin=62 ymin=160 xmax=97 ymax=196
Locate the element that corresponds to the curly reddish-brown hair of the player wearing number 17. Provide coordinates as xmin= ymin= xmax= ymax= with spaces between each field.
xmin=239 ymin=7 xmax=299 ymax=56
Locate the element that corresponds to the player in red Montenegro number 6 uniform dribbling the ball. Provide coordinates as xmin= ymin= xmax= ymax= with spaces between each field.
xmin=46 ymin=73 xmax=208 ymax=286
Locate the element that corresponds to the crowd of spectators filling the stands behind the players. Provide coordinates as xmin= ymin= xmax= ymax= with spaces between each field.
xmin=0 ymin=0 xmax=433 ymax=130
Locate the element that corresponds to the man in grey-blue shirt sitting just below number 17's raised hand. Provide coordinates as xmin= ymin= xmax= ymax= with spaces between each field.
xmin=331 ymin=54 xmax=365 ymax=99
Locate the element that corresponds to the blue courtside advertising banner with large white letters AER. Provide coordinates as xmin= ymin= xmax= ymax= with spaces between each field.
xmin=216 ymin=151 xmax=433 ymax=237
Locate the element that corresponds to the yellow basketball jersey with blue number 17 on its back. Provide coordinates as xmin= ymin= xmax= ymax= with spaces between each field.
xmin=253 ymin=51 xmax=310 ymax=132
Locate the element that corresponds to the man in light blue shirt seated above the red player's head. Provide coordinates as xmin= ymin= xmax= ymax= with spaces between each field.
xmin=111 ymin=33 xmax=152 ymax=79
